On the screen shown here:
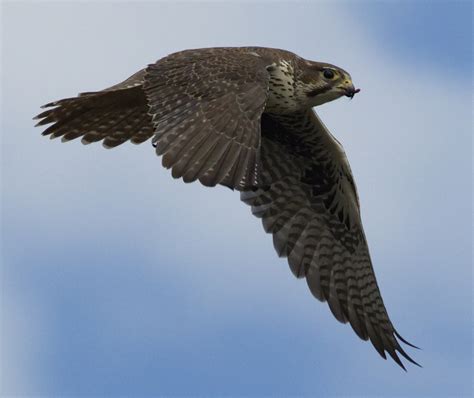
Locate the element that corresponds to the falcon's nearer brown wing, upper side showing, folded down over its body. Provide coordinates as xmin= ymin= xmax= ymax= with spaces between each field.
xmin=144 ymin=48 xmax=269 ymax=189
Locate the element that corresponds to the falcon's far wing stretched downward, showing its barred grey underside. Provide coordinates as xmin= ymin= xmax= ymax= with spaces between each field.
xmin=241 ymin=110 xmax=416 ymax=369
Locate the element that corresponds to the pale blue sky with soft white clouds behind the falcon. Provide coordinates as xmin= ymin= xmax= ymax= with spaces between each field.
xmin=0 ymin=1 xmax=472 ymax=397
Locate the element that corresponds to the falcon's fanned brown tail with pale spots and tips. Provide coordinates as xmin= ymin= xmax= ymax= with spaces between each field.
xmin=36 ymin=70 xmax=153 ymax=148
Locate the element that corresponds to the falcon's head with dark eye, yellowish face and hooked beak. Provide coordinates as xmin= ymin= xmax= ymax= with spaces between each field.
xmin=297 ymin=61 xmax=360 ymax=107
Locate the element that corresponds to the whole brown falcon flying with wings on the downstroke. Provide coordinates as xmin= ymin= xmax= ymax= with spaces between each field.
xmin=36 ymin=47 xmax=418 ymax=369
